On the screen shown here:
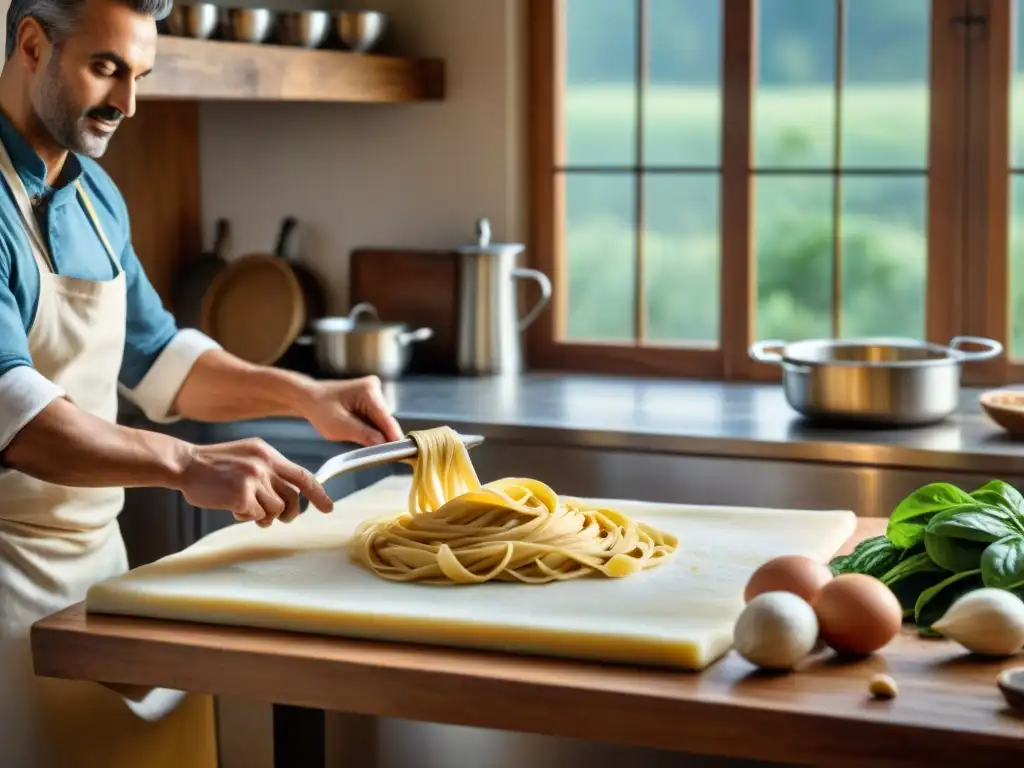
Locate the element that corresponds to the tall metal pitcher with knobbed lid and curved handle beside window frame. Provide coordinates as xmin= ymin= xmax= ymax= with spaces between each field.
xmin=456 ymin=218 xmax=551 ymax=376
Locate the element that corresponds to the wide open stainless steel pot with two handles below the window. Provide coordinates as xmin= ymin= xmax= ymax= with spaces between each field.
xmin=749 ymin=336 xmax=1002 ymax=426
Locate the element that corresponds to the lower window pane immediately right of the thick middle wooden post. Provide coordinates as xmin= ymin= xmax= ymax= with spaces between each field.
xmin=755 ymin=176 xmax=834 ymax=341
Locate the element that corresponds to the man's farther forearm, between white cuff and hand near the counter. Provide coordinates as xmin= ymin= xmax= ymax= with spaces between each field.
xmin=174 ymin=349 xmax=316 ymax=422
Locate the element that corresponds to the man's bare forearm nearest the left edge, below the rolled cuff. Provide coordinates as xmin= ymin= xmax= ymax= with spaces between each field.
xmin=3 ymin=398 xmax=193 ymax=488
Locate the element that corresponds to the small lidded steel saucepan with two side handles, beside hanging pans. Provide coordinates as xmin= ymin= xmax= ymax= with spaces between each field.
xmin=295 ymin=302 xmax=434 ymax=380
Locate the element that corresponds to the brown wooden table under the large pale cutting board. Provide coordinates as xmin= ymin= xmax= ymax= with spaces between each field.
xmin=32 ymin=519 xmax=1024 ymax=767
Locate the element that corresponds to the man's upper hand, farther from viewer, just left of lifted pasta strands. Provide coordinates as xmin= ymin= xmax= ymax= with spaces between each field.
xmin=302 ymin=376 xmax=402 ymax=445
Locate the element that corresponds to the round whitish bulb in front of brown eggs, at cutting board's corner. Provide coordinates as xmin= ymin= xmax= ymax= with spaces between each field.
xmin=733 ymin=592 xmax=818 ymax=670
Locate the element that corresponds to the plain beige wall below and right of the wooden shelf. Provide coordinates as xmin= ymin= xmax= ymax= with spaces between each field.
xmin=201 ymin=0 xmax=525 ymax=309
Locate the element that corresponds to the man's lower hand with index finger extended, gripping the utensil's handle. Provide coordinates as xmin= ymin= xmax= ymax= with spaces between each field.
xmin=180 ymin=438 xmax=334 ymax=527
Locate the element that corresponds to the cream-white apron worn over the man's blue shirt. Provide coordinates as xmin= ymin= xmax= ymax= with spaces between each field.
xmin=0 ymin=142 xmax=217 ymax=768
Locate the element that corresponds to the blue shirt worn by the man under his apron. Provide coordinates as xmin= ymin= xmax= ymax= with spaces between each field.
xmin=0 ymin=112 xmax=177 ymax=389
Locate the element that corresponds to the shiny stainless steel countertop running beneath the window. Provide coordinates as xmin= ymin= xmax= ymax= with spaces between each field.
xmin=121 ymin=373 xmax=1024 ymax=477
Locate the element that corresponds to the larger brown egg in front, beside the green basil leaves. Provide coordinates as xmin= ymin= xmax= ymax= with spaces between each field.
xmin=811 ymin=573 xmax=903 ymax=655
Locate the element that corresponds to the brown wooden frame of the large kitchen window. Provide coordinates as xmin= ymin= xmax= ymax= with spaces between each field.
xmin=527 ymin=0 xmax=1024 ymax=384
